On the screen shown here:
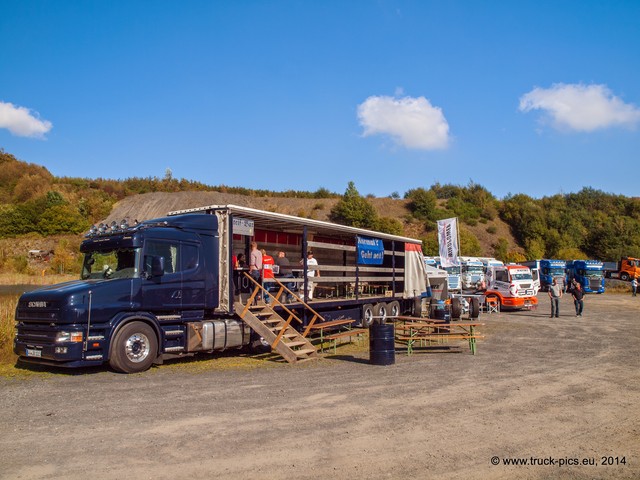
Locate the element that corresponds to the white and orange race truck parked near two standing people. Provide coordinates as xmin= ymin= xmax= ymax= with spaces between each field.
xmin=485 ymin=264 xmax=538 ymax=310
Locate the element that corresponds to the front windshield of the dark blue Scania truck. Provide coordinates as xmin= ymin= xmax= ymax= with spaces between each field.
xmin=81 ymin=248 xmax=140 ymax=280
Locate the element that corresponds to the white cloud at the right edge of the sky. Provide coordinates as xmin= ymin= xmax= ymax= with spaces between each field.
xmin=520 ymin=83 xmax=640 ymax=132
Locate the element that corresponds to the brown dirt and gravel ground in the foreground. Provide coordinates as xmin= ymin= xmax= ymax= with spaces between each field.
xmin=0 ymin=295 xmax=640 ymax=479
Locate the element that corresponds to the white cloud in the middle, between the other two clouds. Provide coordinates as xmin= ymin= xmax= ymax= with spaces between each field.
xmin=358 ymin=96 xmax=449 ymax=150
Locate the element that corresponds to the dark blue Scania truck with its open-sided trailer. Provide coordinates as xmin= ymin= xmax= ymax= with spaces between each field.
xmin=14 ymin=205 xmax=427 ymax=373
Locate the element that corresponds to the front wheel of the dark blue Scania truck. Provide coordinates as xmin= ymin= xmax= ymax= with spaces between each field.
xmin=109 ymin=322 xmax=158 ymax=373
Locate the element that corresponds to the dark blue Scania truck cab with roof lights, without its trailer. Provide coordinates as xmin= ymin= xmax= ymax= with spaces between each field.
xmin=14 ymin=214 xmax=242 ymax=372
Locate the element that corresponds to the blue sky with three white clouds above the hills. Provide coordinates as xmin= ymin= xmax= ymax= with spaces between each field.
xmin=0 ymin=0 xmax=640 ymax=198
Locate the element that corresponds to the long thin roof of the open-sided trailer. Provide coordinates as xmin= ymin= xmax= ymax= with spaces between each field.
xmin=169 ymin=205 xmax=422 ymax=244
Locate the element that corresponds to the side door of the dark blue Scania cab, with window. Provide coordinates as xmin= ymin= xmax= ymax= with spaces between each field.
xmin=142 ymin=239 xmax=182 ymax=312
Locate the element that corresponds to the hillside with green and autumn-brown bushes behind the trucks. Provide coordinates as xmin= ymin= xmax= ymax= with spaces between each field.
xmin=0 ymin=150 xmax=640 ymax=276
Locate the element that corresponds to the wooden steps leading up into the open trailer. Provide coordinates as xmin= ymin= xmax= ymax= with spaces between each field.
xmin=234 ymin=302 xmax=318 ymax=363
